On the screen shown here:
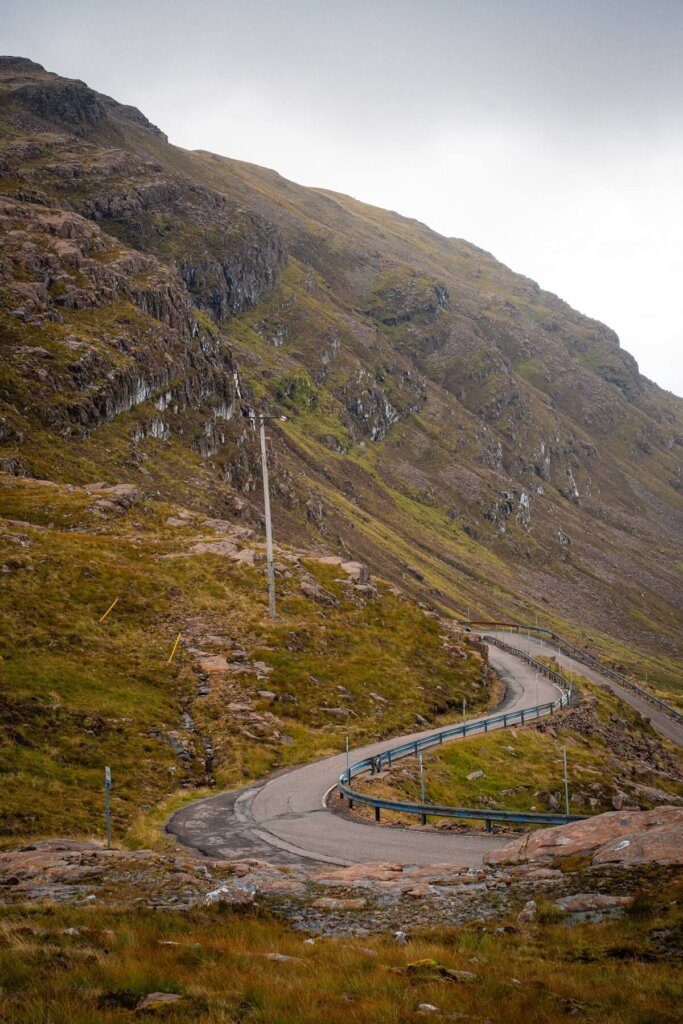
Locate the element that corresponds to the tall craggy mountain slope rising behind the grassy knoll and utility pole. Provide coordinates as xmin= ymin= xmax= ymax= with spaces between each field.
xmin=0 ymin=57 xmax=683 ymax=692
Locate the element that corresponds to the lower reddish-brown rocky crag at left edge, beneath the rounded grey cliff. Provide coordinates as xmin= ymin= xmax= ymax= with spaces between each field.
xmin=0 ymin=193 xmax=244 ymax=446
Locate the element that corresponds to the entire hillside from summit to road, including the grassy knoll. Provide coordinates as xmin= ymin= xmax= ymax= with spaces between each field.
xmin=0 ymin=58 xmax=682 ymax=842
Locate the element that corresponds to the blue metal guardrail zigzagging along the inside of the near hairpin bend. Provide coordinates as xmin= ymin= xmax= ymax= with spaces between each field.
xmin=338 ymin=637 xmax=585 ymax=831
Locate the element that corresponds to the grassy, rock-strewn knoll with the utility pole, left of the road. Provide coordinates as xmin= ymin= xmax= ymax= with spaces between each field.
xmin=0 ymin=479 xmax=490 ymax=844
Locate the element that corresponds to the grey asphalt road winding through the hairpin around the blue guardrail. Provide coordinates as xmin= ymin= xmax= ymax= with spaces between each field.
xmin=167 ymin=645 xmax=559 ymax=867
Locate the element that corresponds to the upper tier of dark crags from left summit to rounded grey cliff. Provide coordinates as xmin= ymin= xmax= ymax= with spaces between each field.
xmin=0 ymin=58 xmax=287 ymax=322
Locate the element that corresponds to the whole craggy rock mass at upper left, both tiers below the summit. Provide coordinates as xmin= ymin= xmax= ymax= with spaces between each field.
xmin=0 ymin=58 xmax=287 ymax=490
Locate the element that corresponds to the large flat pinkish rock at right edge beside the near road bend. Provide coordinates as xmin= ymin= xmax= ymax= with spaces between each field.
xmin=484 ymin=807 xmax=683 ymax=864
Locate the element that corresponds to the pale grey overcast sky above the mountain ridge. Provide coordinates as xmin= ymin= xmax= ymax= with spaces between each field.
xmin=5 ymin=0 xmax=683 ymax=395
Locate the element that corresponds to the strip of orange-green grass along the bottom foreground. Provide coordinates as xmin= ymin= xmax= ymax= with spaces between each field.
xmin=0 ymin=881 xmax=683 ymax=1024
